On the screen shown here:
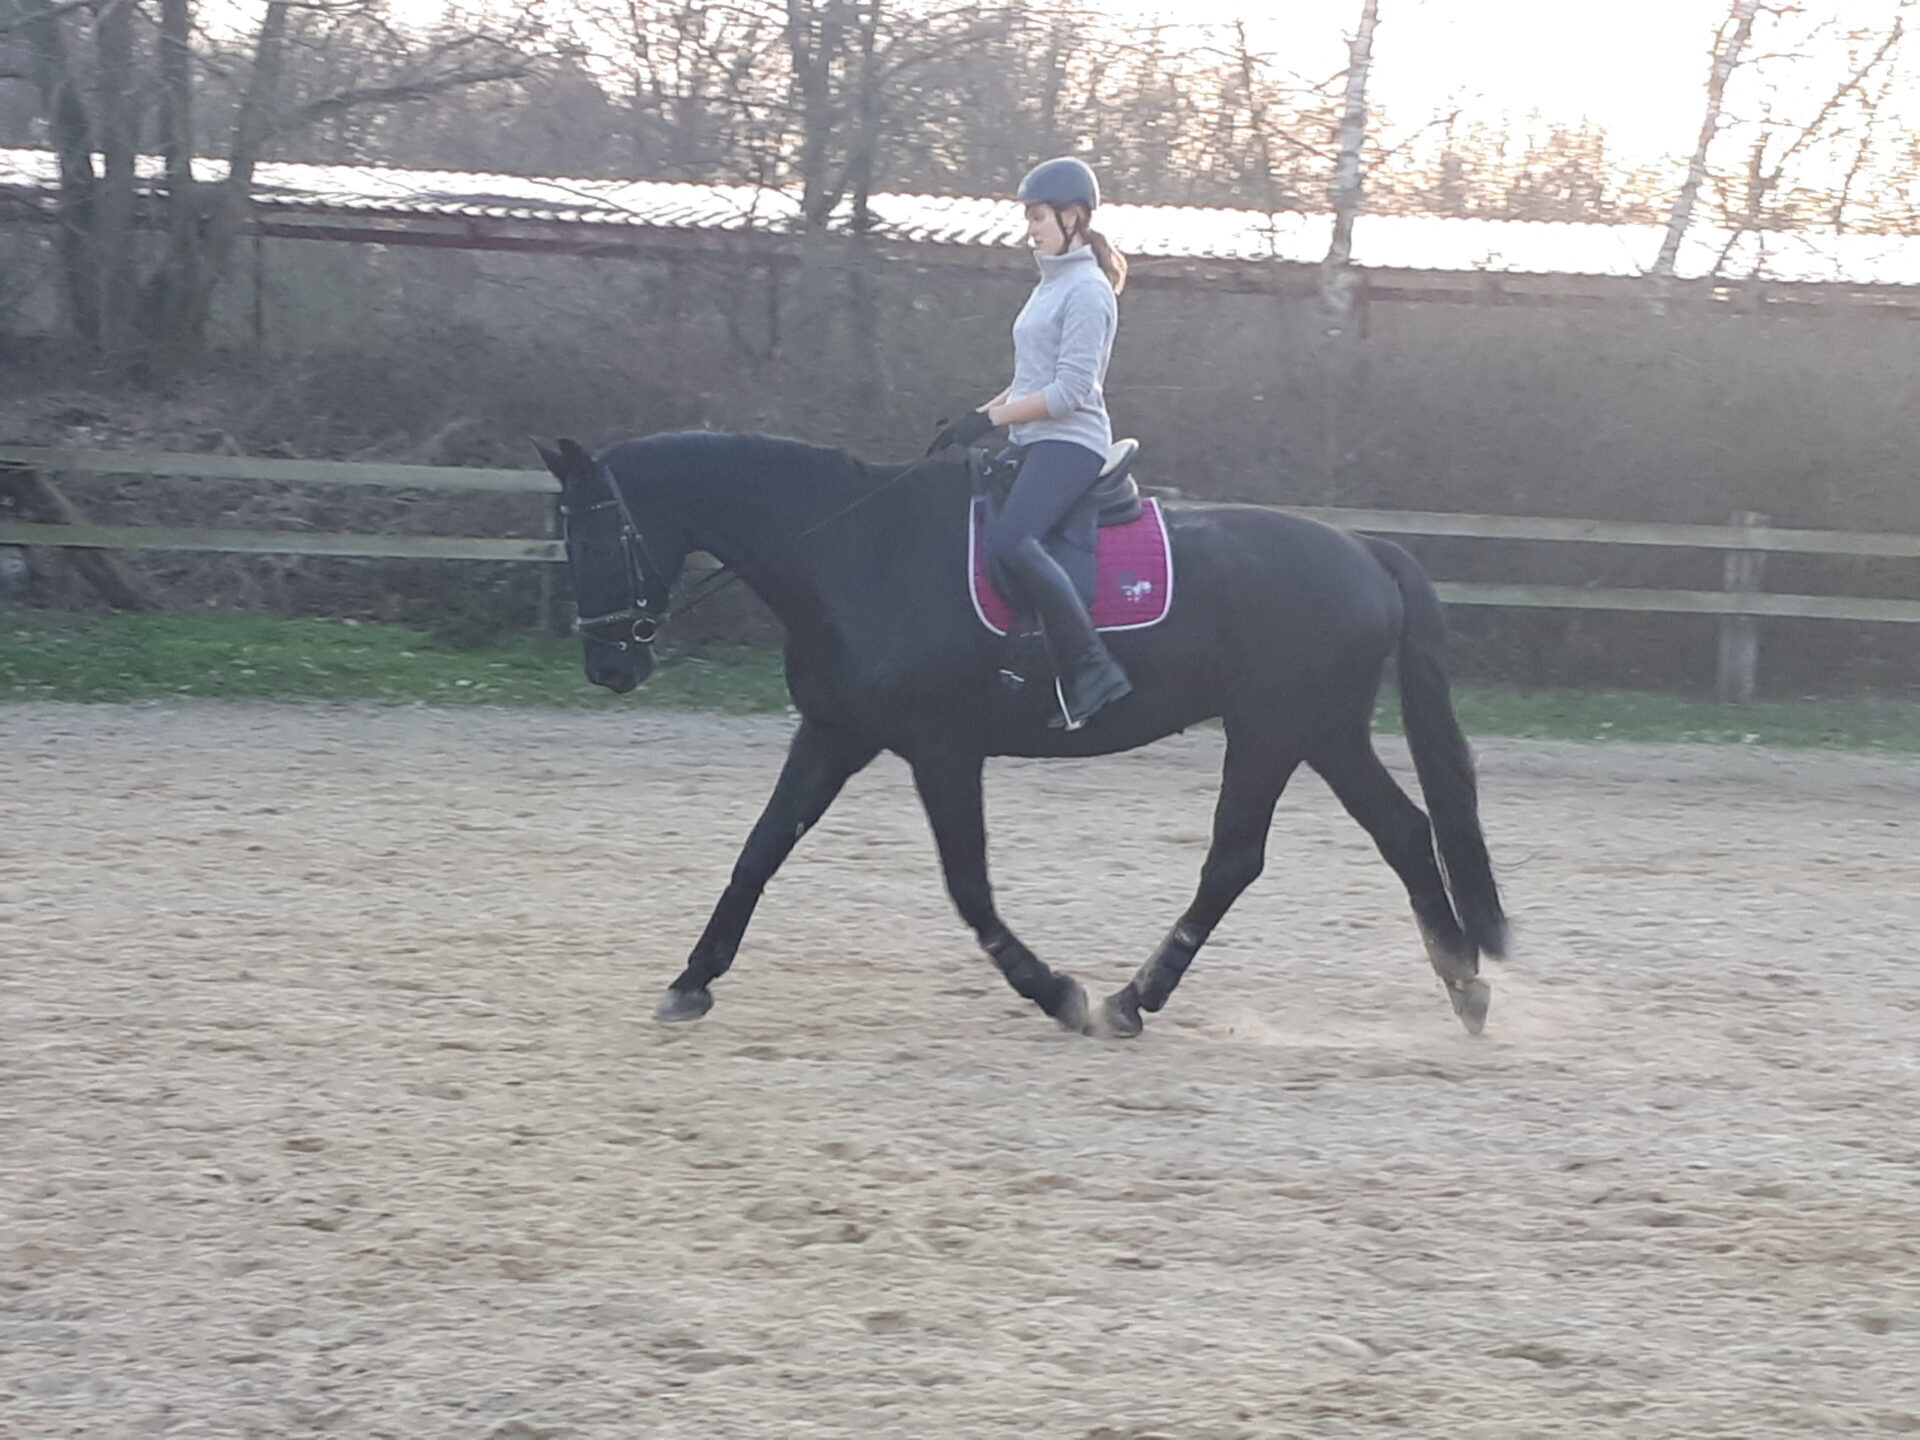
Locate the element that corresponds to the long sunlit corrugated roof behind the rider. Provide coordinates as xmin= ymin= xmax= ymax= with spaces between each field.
xmin=11 ymin=148 xmax=1920 ymax=286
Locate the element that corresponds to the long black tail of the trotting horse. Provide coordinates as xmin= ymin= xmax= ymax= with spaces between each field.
xmin=1361 ymin=536 xmax=1507 ymax=958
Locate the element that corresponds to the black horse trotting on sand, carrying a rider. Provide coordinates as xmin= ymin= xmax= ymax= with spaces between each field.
xmin=540 ymin=432 xmax=1507 ymax=1035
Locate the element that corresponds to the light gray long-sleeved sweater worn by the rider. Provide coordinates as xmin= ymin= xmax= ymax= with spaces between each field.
xmin=1008 ymin=248 xmax=1119 ymax=453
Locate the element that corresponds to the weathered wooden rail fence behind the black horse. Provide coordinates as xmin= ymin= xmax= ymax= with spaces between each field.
xmin=0 ymin=445 xmax=1920 ymax=701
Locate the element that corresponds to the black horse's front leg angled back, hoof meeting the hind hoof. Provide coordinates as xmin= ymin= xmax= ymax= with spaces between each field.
xmin=910 ymin=749 xmax=1089 ymax=1031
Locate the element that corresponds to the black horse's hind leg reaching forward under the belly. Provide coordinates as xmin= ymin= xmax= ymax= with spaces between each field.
xmin=1098 ymin=744 xmax=1300 ymax=1039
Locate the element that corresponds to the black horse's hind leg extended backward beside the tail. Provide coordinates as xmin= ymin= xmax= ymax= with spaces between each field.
xmin=1309 ymin=730 xmax=1494 ymax=1035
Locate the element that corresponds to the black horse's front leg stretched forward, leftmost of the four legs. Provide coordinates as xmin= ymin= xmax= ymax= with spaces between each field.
xmin=655 ymin=720 xmax=879 ymax=1020
